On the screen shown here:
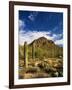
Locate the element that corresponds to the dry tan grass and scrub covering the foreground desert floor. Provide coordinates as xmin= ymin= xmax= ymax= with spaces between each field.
xmin=19 ymin=58 xmax=63 ymax=79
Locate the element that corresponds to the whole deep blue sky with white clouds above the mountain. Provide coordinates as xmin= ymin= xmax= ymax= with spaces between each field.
xmin=19 ymin=11 xmax=63 ymax=46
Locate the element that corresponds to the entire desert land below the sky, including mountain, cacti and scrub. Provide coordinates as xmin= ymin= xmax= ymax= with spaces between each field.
xmin=19 ymin=37 xmax=63 ymax=79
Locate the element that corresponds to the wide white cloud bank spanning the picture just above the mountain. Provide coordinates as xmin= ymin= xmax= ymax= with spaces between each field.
xmin=19 ymin=30 xmax=63 ymax=45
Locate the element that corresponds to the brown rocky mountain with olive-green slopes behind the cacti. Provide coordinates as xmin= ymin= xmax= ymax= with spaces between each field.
xmin=19 ymin=37 xmax=63 ymax=60
